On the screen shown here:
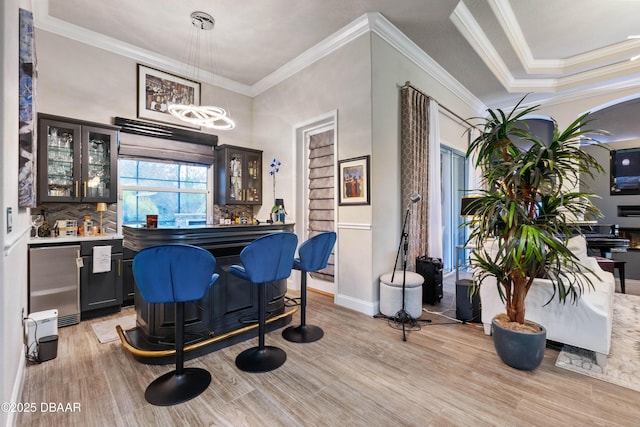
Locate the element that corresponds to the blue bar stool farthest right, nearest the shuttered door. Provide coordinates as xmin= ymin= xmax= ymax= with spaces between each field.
xmin=282 ymin=231 xmax=336 ymax=343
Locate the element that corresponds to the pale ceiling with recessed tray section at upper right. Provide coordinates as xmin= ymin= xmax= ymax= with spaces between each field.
xmin=33 ymin=0 xmax=640 ymax=144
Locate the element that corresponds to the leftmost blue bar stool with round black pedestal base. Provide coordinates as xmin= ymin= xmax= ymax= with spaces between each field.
xmin=133 ymin=245 xmax=218 ymax=406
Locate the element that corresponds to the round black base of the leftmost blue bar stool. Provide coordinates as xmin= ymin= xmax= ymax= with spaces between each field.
xmin=144 ymin=368 xmax=211 ymax=406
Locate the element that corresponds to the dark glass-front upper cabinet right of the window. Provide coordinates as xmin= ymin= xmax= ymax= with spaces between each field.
xmin=215 ymin=145 xmax=262 ymax=205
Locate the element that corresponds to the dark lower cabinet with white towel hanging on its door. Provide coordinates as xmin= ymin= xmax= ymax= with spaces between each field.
xmin=80 ymin=239 xmax=123 ymax=319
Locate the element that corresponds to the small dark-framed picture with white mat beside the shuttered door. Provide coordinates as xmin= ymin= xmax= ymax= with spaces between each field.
xmin=338 ymin=156 xmax=371 ymax=205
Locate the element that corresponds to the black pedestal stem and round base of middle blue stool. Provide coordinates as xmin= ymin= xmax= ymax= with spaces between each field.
xmin=236 ymin=283 xmax=287 ymax=372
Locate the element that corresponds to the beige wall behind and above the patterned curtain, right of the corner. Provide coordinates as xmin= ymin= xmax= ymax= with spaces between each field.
xmin=372 ymin=35 xmax=478 ymax=306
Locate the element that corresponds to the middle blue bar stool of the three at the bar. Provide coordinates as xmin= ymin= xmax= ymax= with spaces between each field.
xmin=229 ymin=232 xmax=298 ymax=372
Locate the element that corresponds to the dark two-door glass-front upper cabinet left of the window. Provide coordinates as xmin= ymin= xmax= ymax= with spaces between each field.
xmin=38 ymin=114 xmax=119 ymax=203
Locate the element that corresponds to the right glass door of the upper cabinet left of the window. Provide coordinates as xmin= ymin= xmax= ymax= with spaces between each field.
xmin=82 ymin=126 xmax=117 ymax=202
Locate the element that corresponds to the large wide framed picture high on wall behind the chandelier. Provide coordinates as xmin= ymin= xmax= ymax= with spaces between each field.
xmin=138 ymin=64 xmax=200 ymax=129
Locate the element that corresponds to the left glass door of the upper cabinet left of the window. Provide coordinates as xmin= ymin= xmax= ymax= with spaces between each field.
xmin=38 ymin=120 xmax=81 ymax=202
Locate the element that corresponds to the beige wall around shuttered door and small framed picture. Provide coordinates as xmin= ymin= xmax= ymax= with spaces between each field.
xmin=253 ymin=34 xmax=380 ymax=314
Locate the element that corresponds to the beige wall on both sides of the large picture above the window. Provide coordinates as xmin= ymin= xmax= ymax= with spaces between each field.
xmin=36 ymin=30 xmax=252 ymax=146
